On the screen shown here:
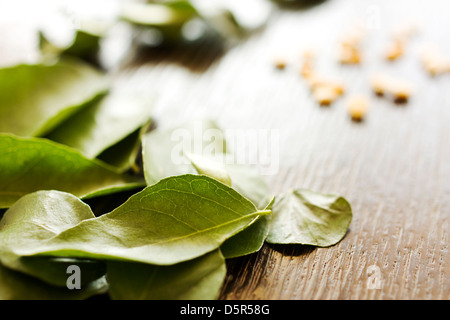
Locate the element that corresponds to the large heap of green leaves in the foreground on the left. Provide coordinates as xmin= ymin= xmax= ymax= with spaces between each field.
xmin=0 ymin=1 xmax=352 ymax=300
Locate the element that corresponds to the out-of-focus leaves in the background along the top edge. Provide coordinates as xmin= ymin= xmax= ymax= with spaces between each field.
xmin=38 ymin=0 xmax=271 ymax=73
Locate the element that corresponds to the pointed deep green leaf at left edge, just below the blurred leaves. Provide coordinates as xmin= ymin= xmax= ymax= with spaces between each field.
xmin=0 ymin=134 xmax=144 ymax=208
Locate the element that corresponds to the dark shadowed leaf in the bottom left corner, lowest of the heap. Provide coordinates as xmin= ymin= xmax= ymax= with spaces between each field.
xmin=0 ymin=264 xmax=108 ymax=300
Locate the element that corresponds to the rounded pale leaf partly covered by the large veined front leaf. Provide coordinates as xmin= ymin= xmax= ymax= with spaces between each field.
xmin=0 ymin=191 xmax=105 ymax=286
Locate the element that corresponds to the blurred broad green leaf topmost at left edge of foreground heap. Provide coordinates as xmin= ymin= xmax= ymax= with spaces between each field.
xmin=0 ymin=59 xmax=108 ymax=136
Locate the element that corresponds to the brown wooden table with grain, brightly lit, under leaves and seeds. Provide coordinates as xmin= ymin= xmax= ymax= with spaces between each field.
xmin=0 ymin=0 xmax=450 ymax=300
